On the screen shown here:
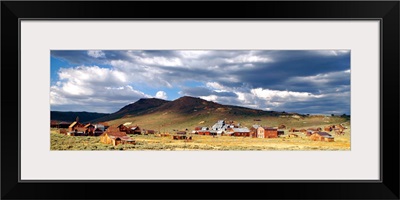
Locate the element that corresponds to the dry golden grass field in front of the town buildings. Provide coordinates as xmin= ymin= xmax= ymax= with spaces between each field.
xmin=50 ymin=124 xmax=351 ymax=151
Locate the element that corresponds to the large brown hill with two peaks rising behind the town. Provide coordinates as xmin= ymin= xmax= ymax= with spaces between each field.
xmin=89 ymin=96 xmax=344 ymax=132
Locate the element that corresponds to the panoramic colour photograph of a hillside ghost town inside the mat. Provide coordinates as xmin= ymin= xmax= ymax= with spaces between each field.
xmin=49 ymin=49 xmax=351 ymax=151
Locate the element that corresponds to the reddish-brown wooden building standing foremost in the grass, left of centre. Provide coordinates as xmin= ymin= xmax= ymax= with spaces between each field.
xmin=100 ymin=128 xmax=135 ymax=146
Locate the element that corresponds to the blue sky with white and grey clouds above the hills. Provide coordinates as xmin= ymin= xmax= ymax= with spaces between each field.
xmin=50 ymin=50 xmax=350 ymax=115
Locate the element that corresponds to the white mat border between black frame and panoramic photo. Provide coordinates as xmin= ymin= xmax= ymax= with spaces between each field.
xmin=20 ymin=20 xmax=381 ymax=181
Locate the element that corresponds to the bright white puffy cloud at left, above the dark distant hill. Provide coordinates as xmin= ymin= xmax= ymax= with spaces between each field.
xmin=50 ymin=66 xmax=151 ymax=112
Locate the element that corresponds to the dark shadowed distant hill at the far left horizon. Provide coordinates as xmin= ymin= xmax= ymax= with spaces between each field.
xmin=50 ymin=111 xmax=109 ymax=123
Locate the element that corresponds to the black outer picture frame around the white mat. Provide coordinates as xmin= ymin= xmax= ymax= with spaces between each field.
xmin=1 ymin=1 xmax=400 ymax=199
